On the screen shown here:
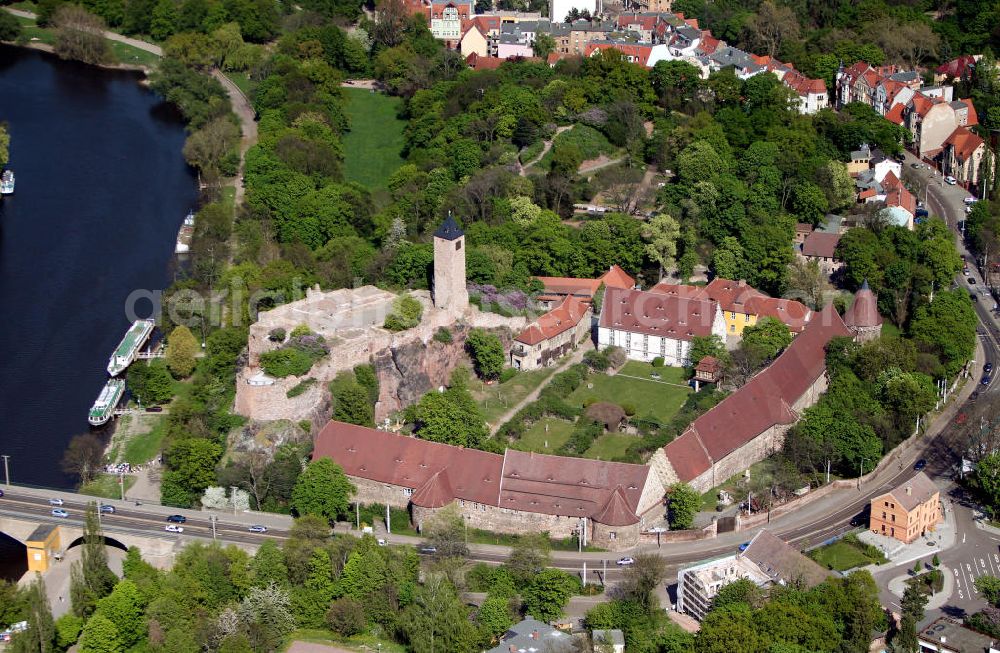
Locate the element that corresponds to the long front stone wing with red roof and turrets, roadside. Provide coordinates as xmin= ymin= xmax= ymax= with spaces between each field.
xmin=313 ymin=422 xmax=663 ymax=551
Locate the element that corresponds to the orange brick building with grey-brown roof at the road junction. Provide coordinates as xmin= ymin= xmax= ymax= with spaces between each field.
xmin=869 ymin=472 xmax=944 ymax=544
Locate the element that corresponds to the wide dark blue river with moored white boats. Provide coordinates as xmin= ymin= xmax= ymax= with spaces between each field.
xmin=0 ymin=45 xmax=197 ymax=488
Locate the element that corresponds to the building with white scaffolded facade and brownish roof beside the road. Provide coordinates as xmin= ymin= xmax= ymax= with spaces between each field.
xmin=677 ymin=530 xmax=833 ymax=621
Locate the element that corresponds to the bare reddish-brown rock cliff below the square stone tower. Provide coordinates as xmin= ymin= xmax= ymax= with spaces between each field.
xmin=373 ymin=326 xmax=513 ymax=422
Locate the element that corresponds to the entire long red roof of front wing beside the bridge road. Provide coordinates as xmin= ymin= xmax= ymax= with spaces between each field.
xmin=313 ymin=422 xmax=650 ymax=525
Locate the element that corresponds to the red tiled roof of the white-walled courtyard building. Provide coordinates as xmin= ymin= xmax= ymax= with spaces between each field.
xmin=600 ymin=288 xmax=718 ymax=340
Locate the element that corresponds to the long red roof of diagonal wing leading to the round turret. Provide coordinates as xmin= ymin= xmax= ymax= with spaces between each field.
xmin=664 ymin=305 xmax=851 ymax=482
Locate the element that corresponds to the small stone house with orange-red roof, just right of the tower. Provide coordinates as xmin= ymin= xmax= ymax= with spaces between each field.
xmin=510 ymin=295 xmax=592 ymax=370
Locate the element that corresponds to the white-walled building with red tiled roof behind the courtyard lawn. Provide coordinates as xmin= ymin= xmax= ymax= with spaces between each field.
xmin=597 ymin=288 xmax=726 ymax=367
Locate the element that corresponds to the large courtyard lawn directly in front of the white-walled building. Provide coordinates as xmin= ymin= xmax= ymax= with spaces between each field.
xmin=567 ymin=361 xmax=691 ymax=422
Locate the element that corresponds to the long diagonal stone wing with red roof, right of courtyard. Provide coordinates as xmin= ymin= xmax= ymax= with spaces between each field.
xmin=649 ymin=305 xmax=852 ymax=492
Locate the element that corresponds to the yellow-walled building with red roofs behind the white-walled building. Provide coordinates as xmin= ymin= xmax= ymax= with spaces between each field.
xmin=650 ymin=277 xmax=812 ymax=336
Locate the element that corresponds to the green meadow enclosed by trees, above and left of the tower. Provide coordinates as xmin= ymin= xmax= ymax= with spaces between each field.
xmin=344 ymin=88 xmax=404 ymax=189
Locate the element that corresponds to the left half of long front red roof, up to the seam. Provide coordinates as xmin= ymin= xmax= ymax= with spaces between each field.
xmin=313 ymin=422 xmax=503 ymax=505
